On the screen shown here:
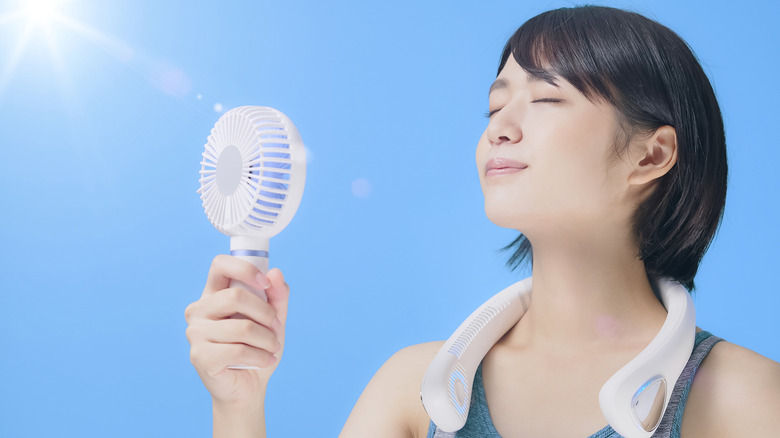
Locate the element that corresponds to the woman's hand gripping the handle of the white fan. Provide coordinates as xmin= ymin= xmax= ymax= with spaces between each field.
xmin=184 ymin=255 xmax=290 ymax=406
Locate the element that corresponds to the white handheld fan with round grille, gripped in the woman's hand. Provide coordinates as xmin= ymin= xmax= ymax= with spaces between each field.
xmin=198 ymin=106 xmax=306 ymax=369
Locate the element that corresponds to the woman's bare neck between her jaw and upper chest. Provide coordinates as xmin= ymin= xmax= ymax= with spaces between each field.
xmin=505 ymin=229 xmax=666 ymax=355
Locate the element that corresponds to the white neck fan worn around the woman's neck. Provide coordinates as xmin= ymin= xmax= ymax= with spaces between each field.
xmin=420 ymin=277 xmax=696 ymax=438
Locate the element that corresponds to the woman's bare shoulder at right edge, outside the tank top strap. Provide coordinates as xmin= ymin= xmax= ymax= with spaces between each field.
xmin=682 ymin=341 xmax=780 ymax=438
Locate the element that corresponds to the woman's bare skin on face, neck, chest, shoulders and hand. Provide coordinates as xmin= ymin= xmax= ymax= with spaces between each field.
xmin=187 ymin=58 xmax=780 ymax=438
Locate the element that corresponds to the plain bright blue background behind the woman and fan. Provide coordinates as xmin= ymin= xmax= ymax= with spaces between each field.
xmin=0 ymin=0 xmax=780 ymax=437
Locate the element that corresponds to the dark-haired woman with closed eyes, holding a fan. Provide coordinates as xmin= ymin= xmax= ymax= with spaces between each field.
xmin=185 ymin=7 xmax=780 ymax=438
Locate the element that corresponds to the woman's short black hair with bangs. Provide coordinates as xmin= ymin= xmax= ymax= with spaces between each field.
xmin=497 ymin=6 xmax=728 ymax=291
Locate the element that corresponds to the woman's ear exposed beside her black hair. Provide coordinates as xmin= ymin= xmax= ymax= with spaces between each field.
xmin=628 ymin=125 xmax=677 ymax=185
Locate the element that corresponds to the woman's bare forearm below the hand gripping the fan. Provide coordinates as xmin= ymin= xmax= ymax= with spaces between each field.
xmin=212 ymin=400 xmax=265 ymax=438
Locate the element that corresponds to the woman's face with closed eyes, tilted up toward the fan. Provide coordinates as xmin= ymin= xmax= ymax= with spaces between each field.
xmin=477 ymin=56 xmax=627 ymax=238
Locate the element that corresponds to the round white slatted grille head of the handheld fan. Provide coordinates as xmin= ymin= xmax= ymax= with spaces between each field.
xmin=198 ymin=107 xmax=297 ymax=236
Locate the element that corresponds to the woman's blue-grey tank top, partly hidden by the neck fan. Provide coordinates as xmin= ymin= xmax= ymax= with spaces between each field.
xmin=427 ymin=331 xmax=723 ymax=438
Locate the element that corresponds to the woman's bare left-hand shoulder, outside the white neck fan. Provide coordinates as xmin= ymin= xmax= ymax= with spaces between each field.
xmin=340 ymin=341 xmax=444 ymax=437
